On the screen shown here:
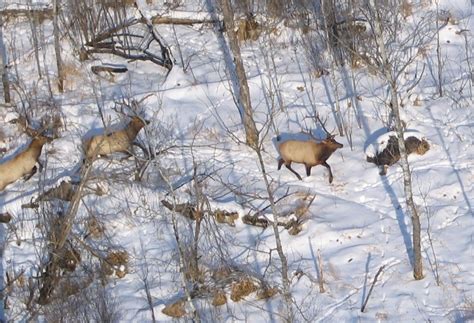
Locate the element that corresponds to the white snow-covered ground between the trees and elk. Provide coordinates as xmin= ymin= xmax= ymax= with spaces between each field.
xmin=0 ymin=0 xmax=474 ymax=322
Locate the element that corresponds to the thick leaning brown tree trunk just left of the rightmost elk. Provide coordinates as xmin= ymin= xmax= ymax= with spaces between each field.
xmin=222 ymin=0 xmax=258 ymax=149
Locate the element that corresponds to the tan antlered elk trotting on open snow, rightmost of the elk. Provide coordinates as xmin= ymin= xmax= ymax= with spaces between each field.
xmin=277 ymin=118 xmax=343 ymax=183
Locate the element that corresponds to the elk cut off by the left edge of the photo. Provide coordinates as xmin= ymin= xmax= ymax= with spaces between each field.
xmin=0 ymin=134 xmax=52 ymax=191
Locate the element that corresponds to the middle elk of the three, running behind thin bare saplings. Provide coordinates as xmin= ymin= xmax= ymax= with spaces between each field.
xmin=84 ymin=116 xmax=150 ymax=160
